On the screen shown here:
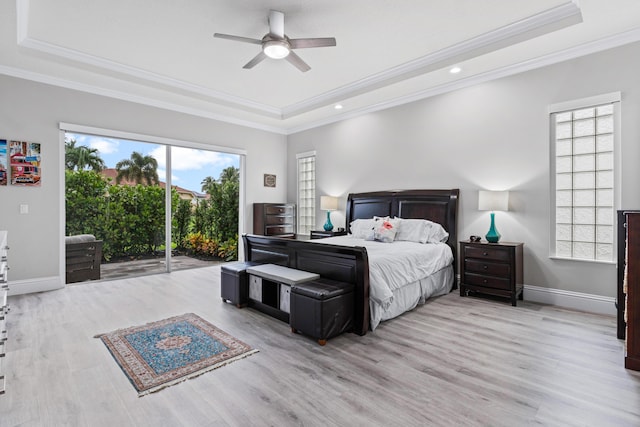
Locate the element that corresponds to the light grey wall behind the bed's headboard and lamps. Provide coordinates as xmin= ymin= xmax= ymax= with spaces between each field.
xmin=288 ymin=43 xmax=640 ymax=297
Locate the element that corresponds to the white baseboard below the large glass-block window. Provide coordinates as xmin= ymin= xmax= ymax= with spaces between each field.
xmin=524 ymin=285 xmax=617 ymax=316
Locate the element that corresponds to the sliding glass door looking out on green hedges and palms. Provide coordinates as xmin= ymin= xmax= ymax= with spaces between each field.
xmin=65 ymin=132 xmax=240 ymax=279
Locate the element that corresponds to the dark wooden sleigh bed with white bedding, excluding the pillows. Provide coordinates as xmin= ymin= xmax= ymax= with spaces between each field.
xmin=243 ymin=189 xmax=459 ymax=335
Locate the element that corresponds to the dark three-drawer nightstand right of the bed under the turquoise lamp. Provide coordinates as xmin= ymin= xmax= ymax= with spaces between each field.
xmin=460 ymin=241 xmax=524 ymax=306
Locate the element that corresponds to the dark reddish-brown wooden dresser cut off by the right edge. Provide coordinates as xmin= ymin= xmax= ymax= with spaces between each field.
xmin=618 ymin=211 xmax=640 ymax=371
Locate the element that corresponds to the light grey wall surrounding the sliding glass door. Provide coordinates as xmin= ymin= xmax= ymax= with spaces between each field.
xmin=0 ymin=76 xmax=286 ymax=293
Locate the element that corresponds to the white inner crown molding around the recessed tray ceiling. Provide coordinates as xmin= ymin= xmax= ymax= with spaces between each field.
xmin=16 ymin=0 xmax=582 ymax=120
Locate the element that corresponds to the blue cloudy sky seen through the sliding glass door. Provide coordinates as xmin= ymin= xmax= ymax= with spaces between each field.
xmin=67 ymin=133 xmax=240 ymax=192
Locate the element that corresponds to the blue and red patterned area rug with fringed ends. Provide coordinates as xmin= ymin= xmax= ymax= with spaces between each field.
xmin=96 ymin=313 xmax=258 ymax=396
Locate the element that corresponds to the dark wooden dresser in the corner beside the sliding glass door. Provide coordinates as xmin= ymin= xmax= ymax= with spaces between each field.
xmin=253 ymin=203 xmax=296 ymax=237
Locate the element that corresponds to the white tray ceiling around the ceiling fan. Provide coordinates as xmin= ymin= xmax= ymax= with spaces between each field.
xmin=0 ymin=0 xmax=640 ymax=133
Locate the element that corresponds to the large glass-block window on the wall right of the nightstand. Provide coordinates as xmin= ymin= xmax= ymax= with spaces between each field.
xmin=550 ymin=93 xmax=620 ymax=262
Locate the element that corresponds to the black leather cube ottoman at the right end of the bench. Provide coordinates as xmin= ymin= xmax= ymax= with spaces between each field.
xmin=289 ymin=279 xmax=354 ymax=345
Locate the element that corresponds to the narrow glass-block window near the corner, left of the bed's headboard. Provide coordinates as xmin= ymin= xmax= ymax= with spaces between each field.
xmin=296 ymin=152 xmax=316 ymax=234
